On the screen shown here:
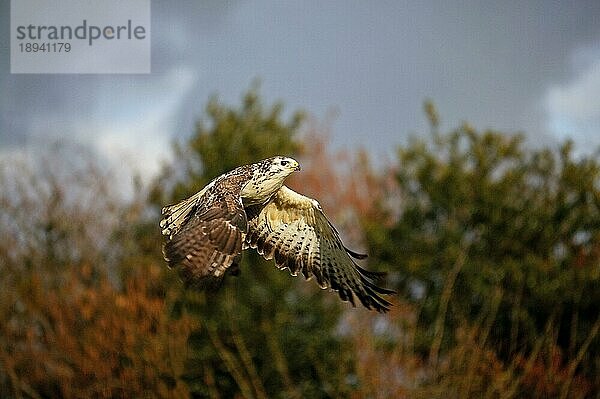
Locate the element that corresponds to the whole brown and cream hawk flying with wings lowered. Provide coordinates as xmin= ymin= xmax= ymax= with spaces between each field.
xmin=160 ymin=156 xmax=394 ymax=312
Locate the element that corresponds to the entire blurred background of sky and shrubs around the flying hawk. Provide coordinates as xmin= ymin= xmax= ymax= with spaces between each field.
xmin=0 ymin=1 xmax=600 ymax=398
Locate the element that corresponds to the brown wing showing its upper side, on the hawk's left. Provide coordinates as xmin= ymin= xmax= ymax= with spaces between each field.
xmin=160 ymin=175 xmax=248 ymax=289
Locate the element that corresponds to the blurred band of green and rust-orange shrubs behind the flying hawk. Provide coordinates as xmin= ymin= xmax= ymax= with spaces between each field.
xmin=0 ymin=89 xmax=600 ymax=398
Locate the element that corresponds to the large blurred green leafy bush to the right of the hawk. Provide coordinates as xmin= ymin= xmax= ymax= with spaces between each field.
xmin=367 ymin=116 xmax=600 ymax=390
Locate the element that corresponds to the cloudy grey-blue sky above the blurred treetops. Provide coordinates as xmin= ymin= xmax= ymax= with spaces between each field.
xmin=0 ymin=0 xmax=600 ymax=182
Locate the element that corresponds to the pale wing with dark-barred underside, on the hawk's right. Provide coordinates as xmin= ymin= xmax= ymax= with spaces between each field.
xmin=246 ymin=186 xmax=394 ymax=312
